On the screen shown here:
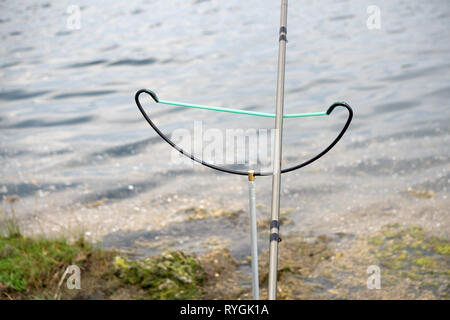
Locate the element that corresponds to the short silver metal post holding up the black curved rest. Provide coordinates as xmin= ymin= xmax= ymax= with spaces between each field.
xmin=248 ymin=170 xmax=259 ymax=300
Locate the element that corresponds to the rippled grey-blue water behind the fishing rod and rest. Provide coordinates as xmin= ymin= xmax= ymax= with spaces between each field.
xmin=0 ymin=0 xmax=450 ymax=252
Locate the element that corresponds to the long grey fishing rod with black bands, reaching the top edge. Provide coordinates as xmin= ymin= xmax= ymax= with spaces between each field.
xmin=268 ymin=0 xmax=287 ymax=300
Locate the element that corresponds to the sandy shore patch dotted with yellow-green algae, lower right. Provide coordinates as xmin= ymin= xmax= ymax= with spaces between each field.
xmin=316 ymin=224 xmax=450 ymax=299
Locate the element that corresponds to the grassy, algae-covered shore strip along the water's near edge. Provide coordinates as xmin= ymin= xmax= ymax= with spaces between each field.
xmin=0 ymin=224 xmax=450 ymax=300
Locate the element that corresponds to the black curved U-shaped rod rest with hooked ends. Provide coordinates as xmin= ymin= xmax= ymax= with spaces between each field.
xmin=134 ymin=89 xmax=353 ymax=176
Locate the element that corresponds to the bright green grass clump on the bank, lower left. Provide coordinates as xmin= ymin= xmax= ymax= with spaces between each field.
xmin=0 ymin=196 xmax=102 ymax=296
